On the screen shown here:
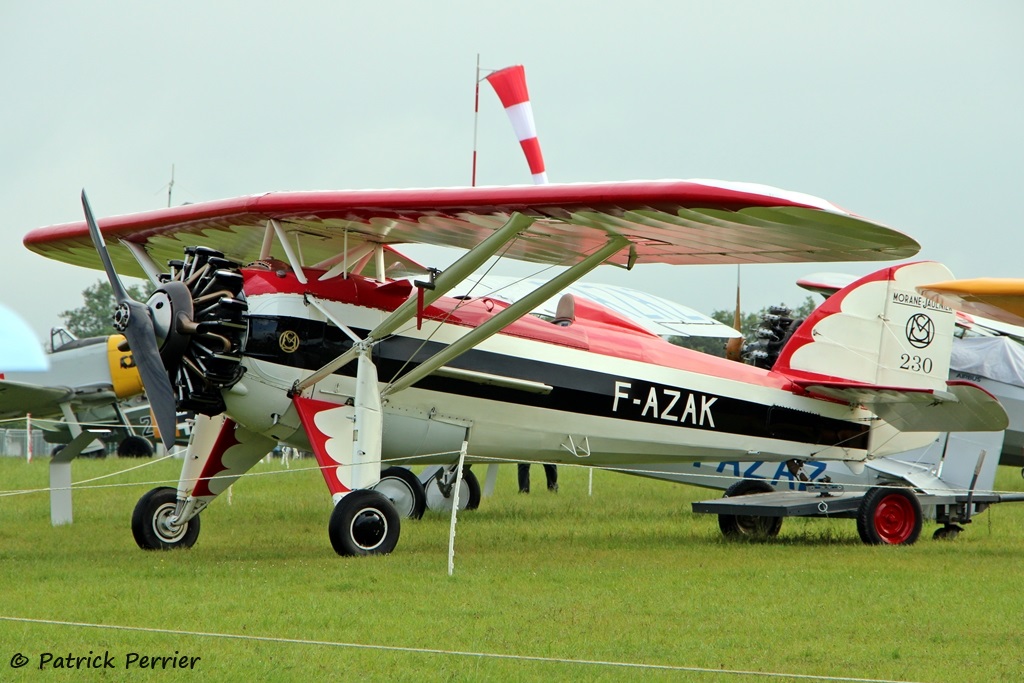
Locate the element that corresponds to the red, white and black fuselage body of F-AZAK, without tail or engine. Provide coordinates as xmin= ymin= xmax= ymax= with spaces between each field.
xmin=225 ymin=268 xmax=870 ymax=466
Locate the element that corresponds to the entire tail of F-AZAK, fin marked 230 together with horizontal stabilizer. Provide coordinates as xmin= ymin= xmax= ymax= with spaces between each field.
xmin=772 ymin=261 xmax=1008 ymax=432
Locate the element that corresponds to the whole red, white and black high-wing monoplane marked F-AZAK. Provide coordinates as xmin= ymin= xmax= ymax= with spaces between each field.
xmin=25 ymin=180 xmax=1007 ymax=555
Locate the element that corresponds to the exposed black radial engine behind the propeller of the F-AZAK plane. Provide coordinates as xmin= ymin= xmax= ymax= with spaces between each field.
xmin=158 ymin=247 xmax=249 ymax=416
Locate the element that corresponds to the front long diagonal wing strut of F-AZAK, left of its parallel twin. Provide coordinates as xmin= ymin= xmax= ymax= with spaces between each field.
xmin=292 ymin=213 xmax=536 ymax=393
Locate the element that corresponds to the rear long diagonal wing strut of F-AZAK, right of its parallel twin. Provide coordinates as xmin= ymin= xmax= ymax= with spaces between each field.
xmin=381 ymin=236 xmax=629 ymax=397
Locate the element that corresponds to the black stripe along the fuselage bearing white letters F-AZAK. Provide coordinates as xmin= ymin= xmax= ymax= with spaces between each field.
xmin=245 ymin=315 xmax=868 ymax=450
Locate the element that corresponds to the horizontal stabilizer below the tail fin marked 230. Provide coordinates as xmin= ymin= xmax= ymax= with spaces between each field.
xmin=797 ymin=381 xmax=1010 ymax=432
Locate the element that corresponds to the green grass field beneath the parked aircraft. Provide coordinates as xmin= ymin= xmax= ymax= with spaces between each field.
xmin=0 ymin=458 xmax=1024 ymax=682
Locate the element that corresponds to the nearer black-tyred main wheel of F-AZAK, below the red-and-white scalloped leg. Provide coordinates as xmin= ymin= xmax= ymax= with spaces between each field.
xmin=328 ymin=488 xmax=401 ymax=556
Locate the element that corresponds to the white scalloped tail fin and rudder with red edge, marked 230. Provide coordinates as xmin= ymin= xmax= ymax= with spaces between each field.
xmin=774 ymin=261 xmax=955 ymax=391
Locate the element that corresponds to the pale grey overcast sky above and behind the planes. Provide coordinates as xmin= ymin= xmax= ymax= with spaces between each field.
xmin=0 ymin=0 xmax=1024 ymax=338
